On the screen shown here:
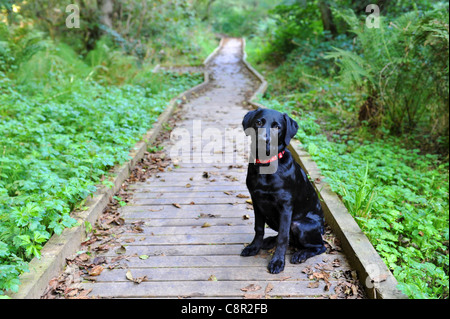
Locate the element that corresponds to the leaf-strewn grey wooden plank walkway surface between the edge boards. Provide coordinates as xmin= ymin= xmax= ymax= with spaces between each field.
xmin=44 ymin=39 xmax=364 ymax=298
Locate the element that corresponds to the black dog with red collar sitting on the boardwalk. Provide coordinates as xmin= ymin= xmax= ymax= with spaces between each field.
xmin=241 ymin=109 xmax=326 ymax=274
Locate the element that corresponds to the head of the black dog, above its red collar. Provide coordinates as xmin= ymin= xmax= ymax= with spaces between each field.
xmin=242 ymin=108 xmax=298 ymax=155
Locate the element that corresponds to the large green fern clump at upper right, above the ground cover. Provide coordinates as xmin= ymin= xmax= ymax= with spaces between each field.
xmin=327 ymin=5 xmax=449 ymax=150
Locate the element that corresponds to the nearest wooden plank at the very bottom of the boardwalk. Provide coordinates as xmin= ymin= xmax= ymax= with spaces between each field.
xmin=82 ymin=280 xmax=334 ymax=299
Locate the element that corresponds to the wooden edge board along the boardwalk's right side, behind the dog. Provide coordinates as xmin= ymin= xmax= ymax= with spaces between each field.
xmin=243 ymin=39 xmax=408 ymax=299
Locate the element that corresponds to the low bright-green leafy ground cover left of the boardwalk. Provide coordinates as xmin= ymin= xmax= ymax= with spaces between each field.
xmin=0 ymin=74 xmax=199 ymax=291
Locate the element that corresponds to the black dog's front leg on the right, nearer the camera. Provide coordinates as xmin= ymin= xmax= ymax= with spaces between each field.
xmin=267 ymin=205 xmax=292 ymax=274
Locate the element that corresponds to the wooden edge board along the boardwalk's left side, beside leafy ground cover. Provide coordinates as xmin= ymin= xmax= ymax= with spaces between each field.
xmin=8 ymin=45 xmax=223 ymax=299
